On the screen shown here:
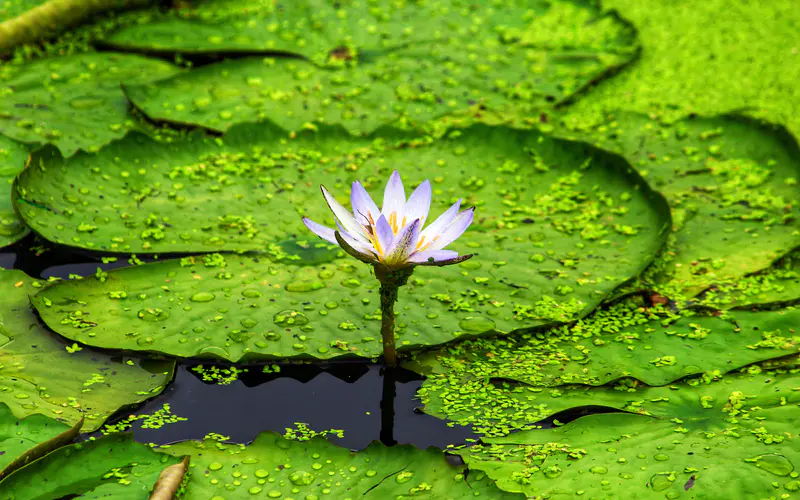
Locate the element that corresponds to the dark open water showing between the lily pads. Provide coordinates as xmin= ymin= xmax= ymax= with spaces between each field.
xmin=0 ymin=236 xmax=477 ymax=449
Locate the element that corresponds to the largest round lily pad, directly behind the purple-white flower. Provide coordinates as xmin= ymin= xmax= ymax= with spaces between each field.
xmin=23 ymin=125 xmax=669 ymax=360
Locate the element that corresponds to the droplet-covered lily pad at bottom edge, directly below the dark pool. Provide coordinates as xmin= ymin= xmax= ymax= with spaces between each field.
xmin=162 ymin=432 xmax=522 ymax=500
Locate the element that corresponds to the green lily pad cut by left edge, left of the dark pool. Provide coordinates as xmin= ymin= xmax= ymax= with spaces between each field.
xmin=0 ymin=271 xmax=175 ymax=432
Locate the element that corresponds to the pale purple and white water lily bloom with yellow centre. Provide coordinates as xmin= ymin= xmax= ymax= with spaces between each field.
xmin=303 ymin=170 xmax=475 ymax=270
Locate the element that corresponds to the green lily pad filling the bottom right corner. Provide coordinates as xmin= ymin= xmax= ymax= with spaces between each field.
xmin=462 ymin=373 xmax=800 ymax=499
